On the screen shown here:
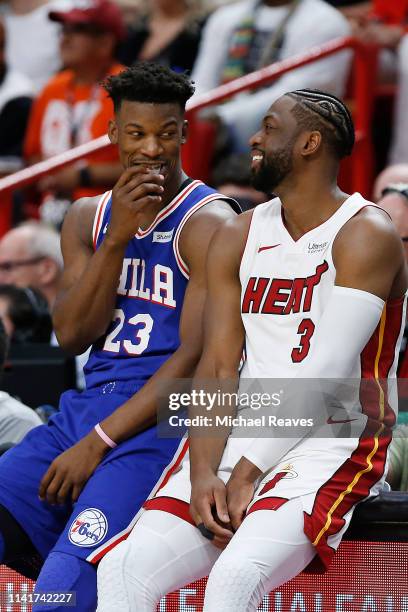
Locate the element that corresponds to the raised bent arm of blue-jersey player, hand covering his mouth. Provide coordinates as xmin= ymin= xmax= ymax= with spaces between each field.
xmin=53 ymin=169 xmax=163 ymax=354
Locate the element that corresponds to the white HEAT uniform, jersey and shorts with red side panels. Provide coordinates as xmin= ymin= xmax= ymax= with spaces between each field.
xmin=145 ymin=194 xmax=405 ymax=566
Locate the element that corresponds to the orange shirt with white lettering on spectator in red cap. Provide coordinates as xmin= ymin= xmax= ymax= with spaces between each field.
xmin=24 ymin=64 xmax=124 ymax=199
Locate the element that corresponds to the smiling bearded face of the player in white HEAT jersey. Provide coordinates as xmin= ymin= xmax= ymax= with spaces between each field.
xmin=250 ymin=96 xmax=299 ymax=193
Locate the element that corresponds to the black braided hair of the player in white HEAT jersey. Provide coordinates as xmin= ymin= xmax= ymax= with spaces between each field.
xmin=286 ymin=89 xmax=355 ymax=160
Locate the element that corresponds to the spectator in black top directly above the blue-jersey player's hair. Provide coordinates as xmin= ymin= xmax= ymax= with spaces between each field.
xmin=119 ymin=0 xmax=204 ymax=71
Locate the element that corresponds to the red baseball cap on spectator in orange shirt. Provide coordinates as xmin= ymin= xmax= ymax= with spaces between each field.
xmin=48 ymin=0 xmax=126 ymax=40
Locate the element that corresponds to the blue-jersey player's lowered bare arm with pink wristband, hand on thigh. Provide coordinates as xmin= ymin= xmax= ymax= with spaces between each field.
xmin=39 ymin=202 xmax=235 ymax=504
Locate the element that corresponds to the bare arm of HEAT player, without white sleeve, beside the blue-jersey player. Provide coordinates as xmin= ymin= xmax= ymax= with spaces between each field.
xmin=186 ymin=214 xmax=250 ymax=547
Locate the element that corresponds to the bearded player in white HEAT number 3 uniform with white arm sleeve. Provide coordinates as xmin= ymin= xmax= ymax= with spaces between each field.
xmin=98 ymin=90 xmax=407 ymax=612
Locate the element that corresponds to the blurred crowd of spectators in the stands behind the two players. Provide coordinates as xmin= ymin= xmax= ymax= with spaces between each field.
xmin=0 ymin=0 xmax=408 ymax=488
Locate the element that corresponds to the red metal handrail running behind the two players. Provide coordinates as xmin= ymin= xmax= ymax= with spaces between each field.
xmin=0 ymin=37 xmax=376 ymax=231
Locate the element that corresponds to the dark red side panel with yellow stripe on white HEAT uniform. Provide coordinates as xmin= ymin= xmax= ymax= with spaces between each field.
xmin=305 ymin=299 xmax=404 ymax=567
